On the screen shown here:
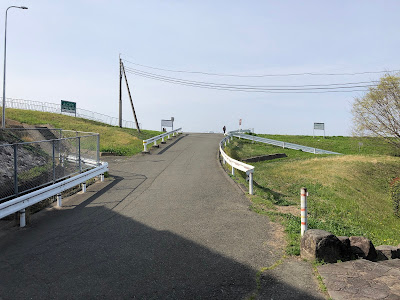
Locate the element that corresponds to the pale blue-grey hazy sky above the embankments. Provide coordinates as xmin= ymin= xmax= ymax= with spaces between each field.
xmin=0 ymin=0 xmax=400 ymax=135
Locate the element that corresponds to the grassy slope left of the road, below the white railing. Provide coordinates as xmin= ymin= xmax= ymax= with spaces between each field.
xmin=6 ymin=108 xmax=161 ymax=155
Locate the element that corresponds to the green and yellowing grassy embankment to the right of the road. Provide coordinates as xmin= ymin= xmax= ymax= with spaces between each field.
xmin=223 ymin=135 xmax=400 ymax=255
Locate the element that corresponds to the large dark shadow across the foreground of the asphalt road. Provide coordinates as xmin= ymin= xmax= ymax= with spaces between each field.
xmin=0 ymin=190 xmax=317 ymax=300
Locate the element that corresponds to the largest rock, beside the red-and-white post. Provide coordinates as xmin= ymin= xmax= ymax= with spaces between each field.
xmin=300 ymin=229 xmax=351 ymax=263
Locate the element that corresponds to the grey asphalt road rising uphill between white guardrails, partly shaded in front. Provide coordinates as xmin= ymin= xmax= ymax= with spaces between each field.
xmin=0 ymin=134 xmax=324 ymax=299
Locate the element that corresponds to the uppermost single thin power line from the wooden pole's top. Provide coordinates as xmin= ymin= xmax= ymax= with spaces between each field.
xmin=122 ymin=59 xmax=400 ymax=78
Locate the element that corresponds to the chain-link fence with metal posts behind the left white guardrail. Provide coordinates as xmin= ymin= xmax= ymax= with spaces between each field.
xmin=0 ymin=128 xmax=100 ymax=202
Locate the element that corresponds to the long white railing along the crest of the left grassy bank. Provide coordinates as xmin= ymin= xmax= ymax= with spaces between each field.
xmin=0 ymin=97 xmax=136 ymax=128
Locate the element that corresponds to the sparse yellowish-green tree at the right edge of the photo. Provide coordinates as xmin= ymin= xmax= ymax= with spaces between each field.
xmin=352 ymin=74 xmax=400 ymax=148
